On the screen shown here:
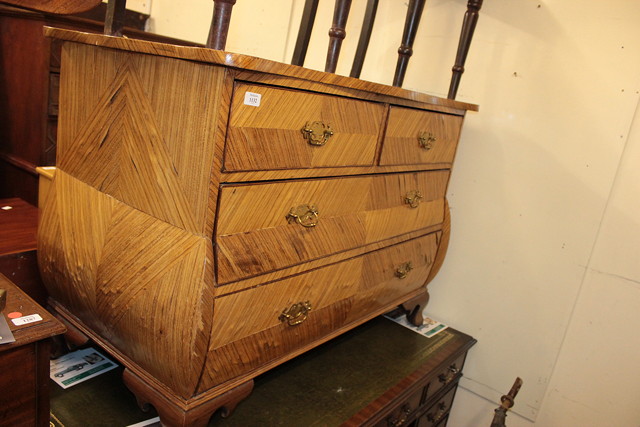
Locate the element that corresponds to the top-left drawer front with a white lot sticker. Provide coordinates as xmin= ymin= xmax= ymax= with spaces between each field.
xmin=224 ymin=83 xmax=384 ymax=171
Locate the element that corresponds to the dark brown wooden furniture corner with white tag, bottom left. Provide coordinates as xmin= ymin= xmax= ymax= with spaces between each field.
xmin=0 ymin=274 xmax=65 ymax=427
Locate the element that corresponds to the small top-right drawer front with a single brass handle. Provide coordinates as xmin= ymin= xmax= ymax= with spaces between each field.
xmin=380 ymin=107 xmax=462 ymax=166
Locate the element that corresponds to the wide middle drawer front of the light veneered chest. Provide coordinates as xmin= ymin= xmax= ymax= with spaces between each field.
xmin=216 ymin=171 xmax=449 ymax=284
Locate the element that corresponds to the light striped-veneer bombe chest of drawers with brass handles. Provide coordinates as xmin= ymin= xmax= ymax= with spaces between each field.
xmin=38 ymin=29 xmax=476 ymax=424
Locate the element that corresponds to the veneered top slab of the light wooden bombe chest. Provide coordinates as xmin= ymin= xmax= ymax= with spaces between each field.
xmin=45 ymin=27 xmax=478 ymax=111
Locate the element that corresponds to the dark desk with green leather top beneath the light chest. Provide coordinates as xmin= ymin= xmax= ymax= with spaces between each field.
xmin=209 ymin=317 xmax=475 ymax=427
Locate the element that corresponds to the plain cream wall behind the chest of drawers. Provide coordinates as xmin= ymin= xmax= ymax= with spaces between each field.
xmin=145 ymin=0 xmax=640 ymax=427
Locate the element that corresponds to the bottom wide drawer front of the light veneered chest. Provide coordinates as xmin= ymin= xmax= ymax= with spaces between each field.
xmin=204 ymin=232 xmax=439 ymax=384
